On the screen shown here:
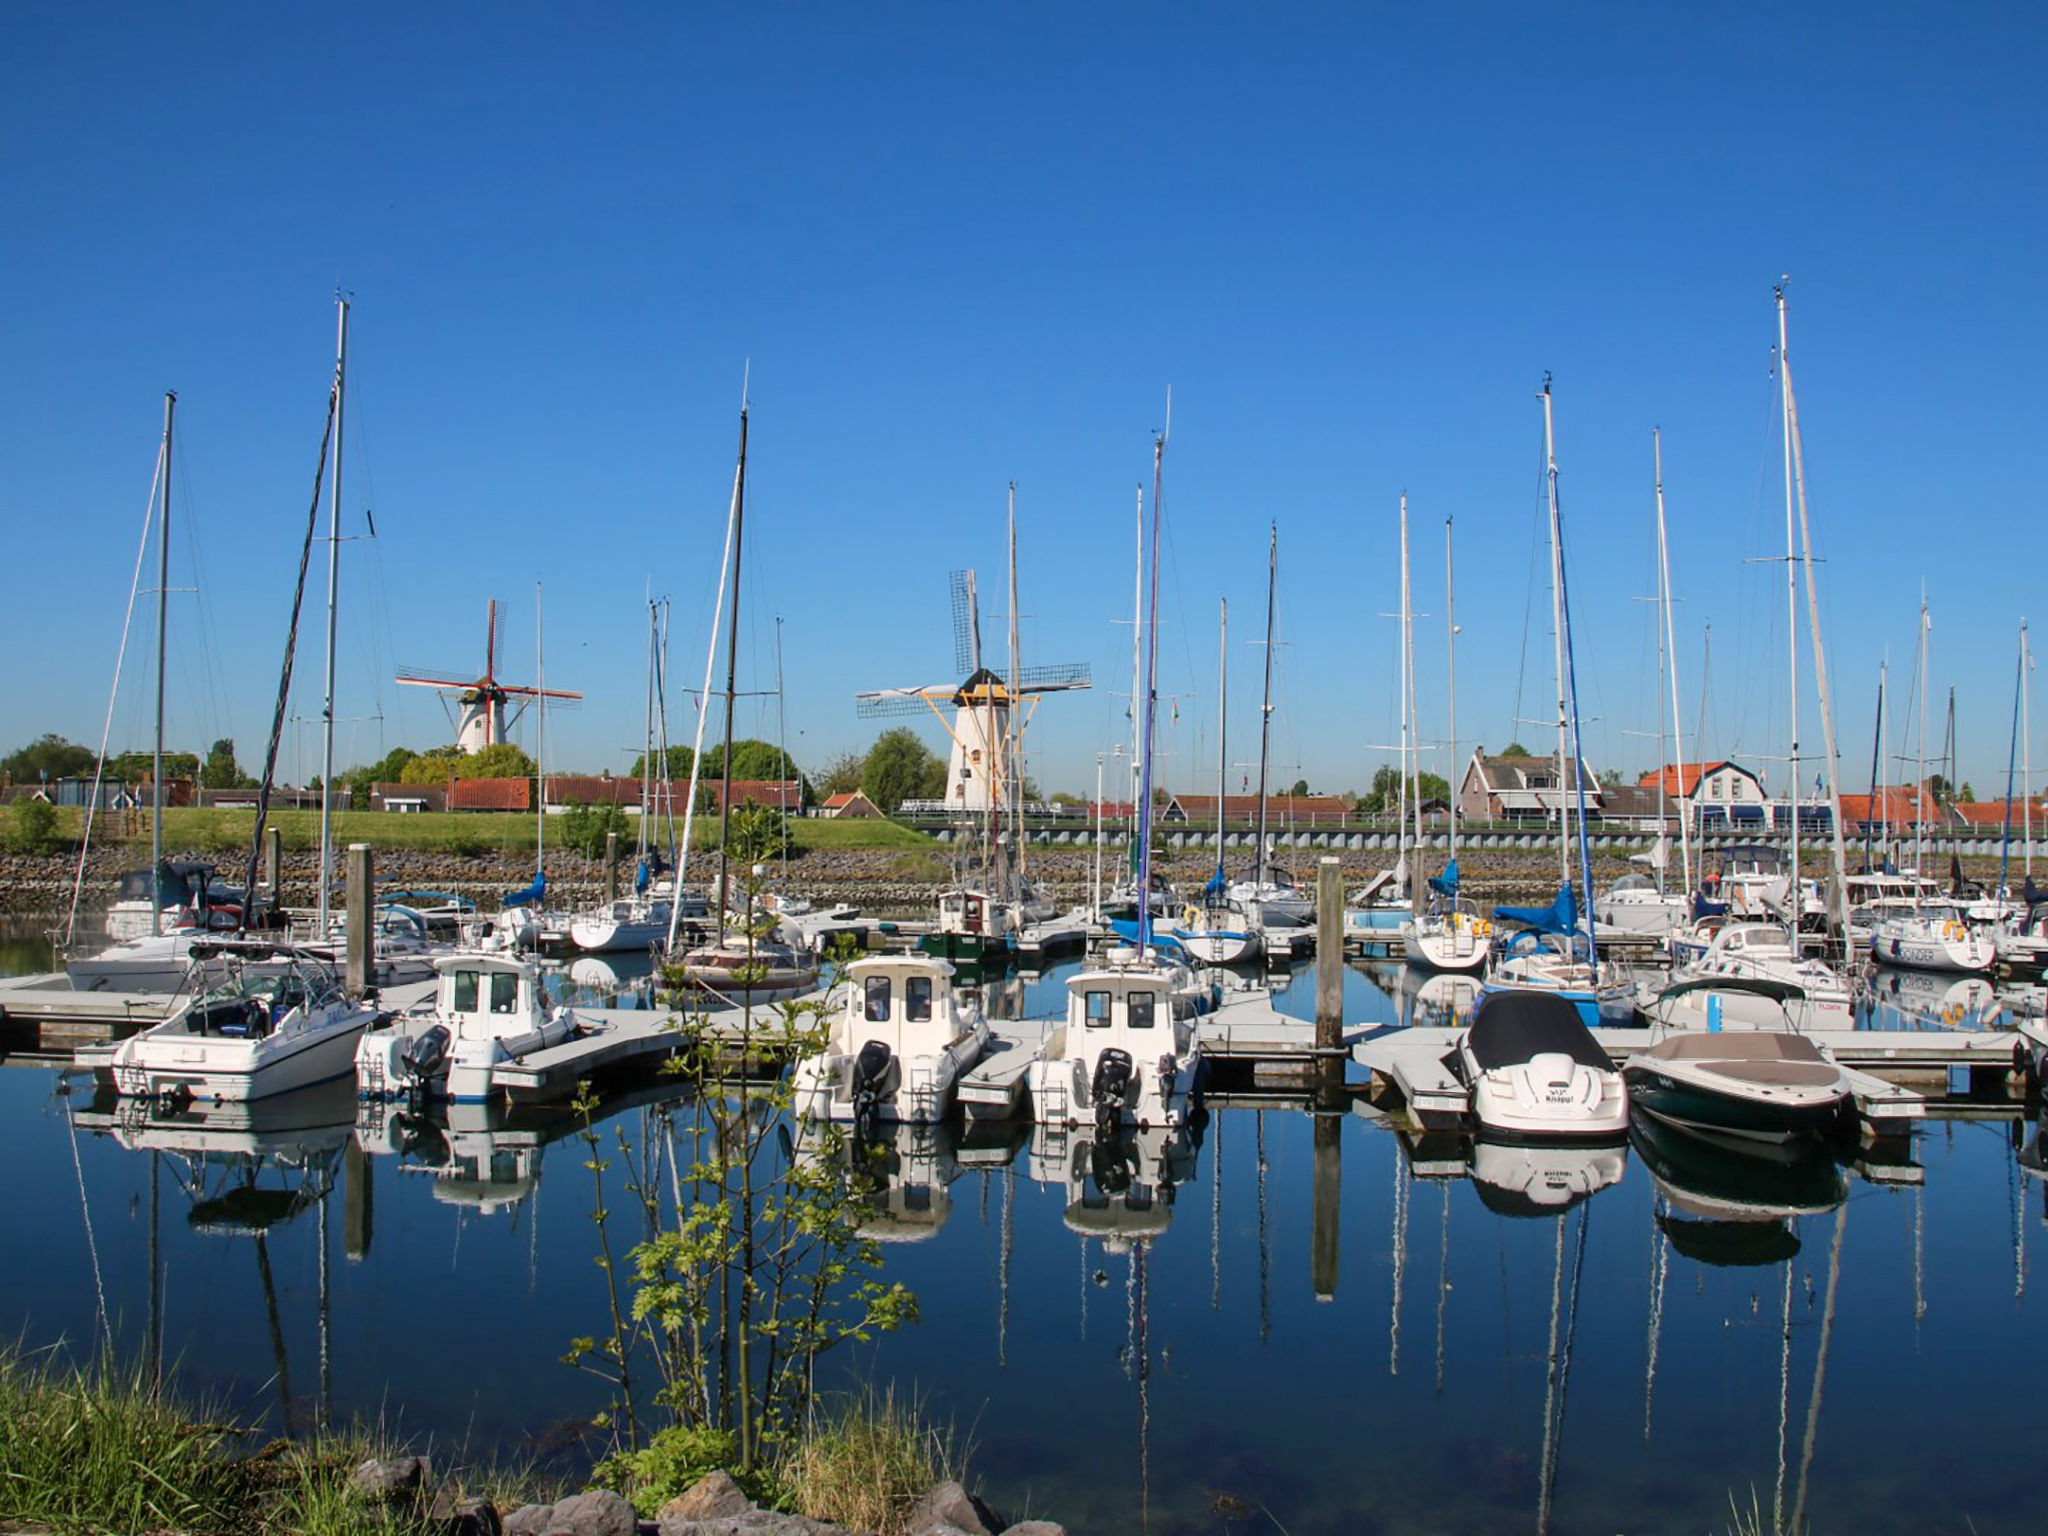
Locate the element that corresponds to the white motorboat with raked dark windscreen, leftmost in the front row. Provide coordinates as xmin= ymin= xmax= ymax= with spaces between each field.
xmin=94 ymin=940 xmax=377 ymax=1100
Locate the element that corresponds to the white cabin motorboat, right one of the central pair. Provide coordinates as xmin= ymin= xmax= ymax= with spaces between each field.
xmin=1026 ymin=944 xmax=1202 ymax=1126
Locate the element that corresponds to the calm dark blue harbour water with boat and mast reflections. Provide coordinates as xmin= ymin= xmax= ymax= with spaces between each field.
xmin=0 ymin=921 xmax=2048 ymax=1536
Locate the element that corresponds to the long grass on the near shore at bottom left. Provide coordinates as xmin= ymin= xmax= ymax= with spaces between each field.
xmin=0 ymin=1350 xmax=961 ymax=1536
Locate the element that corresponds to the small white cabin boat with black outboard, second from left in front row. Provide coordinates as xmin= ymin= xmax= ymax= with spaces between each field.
xmin=356 ymin=948 xmax=580 ymax=1104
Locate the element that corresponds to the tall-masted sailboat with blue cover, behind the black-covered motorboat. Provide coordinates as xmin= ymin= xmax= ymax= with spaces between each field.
xmin=1483 ymin=375 xmax=1634 ymax=1024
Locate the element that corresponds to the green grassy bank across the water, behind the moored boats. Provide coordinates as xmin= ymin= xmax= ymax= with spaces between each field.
xmin=19 ymin=807 xmax=936 ymax=862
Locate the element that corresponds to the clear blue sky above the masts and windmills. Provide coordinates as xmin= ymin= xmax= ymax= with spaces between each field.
xmin=0 ymin=4 xmax=2048 ymax=797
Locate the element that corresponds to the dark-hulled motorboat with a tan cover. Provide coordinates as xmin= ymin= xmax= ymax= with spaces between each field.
xmin=1622 ymin=1028 xmax=1849 ymax=1141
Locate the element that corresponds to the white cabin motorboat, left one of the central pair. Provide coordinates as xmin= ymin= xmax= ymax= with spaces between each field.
xmin=793 ymin=952 xmax=989 ymax=1126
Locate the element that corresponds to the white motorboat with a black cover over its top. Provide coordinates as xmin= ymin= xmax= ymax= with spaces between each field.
xmin=1448 ymin=991 xmax=1628 ymax=1141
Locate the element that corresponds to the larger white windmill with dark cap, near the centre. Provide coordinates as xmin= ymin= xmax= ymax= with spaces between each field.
xmin=854 ymin=571 xmax=1090 ymax=815
